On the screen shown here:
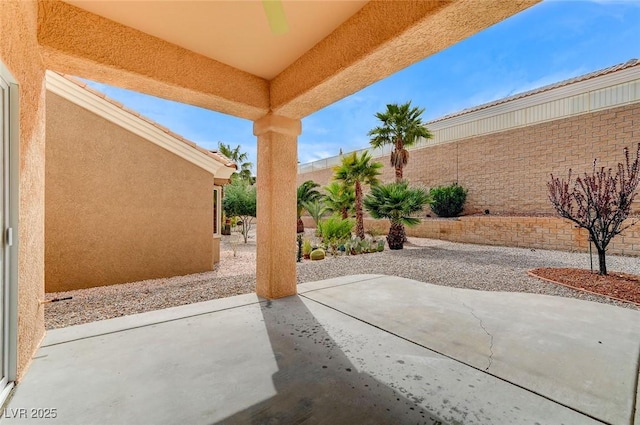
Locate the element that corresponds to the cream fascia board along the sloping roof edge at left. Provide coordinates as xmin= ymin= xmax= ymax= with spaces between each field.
xmin=46 ymin=71 xmax=228 ymax=179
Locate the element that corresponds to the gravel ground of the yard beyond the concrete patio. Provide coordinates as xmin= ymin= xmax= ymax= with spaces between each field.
xmin=45 ymin=227 xmax=640 ymax=329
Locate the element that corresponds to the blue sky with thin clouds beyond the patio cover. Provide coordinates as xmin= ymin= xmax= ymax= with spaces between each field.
xmin=85 ymin=0 xmax=640 ymax=170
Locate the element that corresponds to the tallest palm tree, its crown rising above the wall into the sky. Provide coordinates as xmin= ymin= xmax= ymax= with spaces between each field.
xmin=369 ymin=101 xmax=433 ymax=182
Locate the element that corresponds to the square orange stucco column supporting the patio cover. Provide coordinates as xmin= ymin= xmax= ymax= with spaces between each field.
xmin=253 ymin=114 xmax=302 ymax=299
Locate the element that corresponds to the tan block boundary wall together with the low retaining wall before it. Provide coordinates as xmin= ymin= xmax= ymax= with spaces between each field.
xmin=298 ymin=103 xmax=640 ymax=256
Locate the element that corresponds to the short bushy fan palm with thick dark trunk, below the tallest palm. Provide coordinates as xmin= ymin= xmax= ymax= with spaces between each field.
xmin=364 ymin=181 xmax=429 ymax=249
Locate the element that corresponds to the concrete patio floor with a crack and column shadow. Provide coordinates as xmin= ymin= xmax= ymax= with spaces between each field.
xmin=0 ymin=275 xmax=640 ymax=425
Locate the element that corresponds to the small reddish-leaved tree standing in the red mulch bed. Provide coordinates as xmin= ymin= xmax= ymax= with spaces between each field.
xmin=547 ymin=143 xmax=640 ymax=275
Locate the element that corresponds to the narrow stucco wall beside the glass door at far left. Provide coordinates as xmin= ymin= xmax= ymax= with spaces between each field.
xmin=0 ymin=0 xmax=45 ymax=378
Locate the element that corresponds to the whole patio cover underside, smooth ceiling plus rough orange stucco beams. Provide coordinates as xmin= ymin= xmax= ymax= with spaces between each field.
xmin=38 ymin=0 xmax=539 ymax=120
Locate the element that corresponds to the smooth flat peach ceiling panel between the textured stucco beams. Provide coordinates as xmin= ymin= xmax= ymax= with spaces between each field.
xmin=65 ymin=0 xmax=368 ymax=80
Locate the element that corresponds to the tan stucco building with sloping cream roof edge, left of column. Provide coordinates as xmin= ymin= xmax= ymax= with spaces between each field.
xmin=45 ymin=72 xmax=236 ymax=292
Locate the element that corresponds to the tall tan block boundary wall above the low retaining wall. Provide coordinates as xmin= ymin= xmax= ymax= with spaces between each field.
xmin=298 ymin=103 xmax=640 ymax=215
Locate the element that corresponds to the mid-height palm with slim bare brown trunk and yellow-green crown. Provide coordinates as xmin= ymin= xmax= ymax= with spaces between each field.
xmin=333 ymin=151 xmax=382 ymax=239
